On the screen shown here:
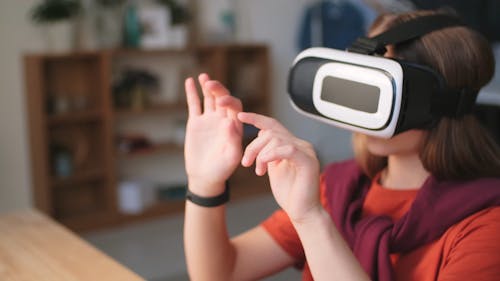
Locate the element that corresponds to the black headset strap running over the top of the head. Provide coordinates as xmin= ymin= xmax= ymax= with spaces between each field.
xmin=347 ymin=14 xmax=464 ymax=55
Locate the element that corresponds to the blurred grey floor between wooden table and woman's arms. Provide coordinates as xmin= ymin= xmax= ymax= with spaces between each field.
xmin=84 ymin=192 xmax=300 ymax=281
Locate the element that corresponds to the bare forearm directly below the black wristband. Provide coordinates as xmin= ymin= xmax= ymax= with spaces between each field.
xmin=184 ymin=183 xmax=235 ymax=281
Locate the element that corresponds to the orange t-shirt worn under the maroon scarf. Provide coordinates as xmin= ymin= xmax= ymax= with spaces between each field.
xmin=262 ymin=174 xmax=500 ymax=281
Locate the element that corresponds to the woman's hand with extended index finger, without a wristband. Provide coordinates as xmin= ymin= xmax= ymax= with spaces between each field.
xmin=238 ymin=112 xmax=321 ymax=221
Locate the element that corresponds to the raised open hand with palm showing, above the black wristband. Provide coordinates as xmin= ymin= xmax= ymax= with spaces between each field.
xmin=184 ymin=74 xmax=243 ymax=196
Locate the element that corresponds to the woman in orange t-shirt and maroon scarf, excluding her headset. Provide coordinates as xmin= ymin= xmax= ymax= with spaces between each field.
xmin=184 ymin=11 xmax=500 ymax=280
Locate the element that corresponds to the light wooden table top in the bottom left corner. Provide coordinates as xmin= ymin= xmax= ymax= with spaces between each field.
xmin=0 ymin=210 xmax=144 ymax=281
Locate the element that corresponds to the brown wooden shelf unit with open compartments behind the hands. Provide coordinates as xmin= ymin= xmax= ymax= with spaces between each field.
xmin=24 ymin=44 xmax=270 ymax=231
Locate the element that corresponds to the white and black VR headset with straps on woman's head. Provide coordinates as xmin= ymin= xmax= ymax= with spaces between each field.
xmin=288 ymin=15 xmax=478 ymax=138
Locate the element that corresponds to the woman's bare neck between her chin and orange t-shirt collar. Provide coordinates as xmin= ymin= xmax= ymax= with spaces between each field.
xmin=381 ymin=154 xmax=429 ymax=190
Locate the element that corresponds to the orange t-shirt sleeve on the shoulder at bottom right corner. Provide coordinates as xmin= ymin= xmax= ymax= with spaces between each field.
xmin=437 ymin=207 xmax=500 ymax=281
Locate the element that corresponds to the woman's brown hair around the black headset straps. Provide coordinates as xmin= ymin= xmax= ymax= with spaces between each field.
xmin=353 ymin=11 xmax=500 ymax=180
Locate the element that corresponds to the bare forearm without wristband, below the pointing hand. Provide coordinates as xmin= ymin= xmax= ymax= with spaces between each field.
xmin=293 ymin=208 xmax=370 ymax=281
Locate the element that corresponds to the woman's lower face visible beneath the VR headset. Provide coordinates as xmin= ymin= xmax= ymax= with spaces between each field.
xmin=365 ymin=130 xmax=426 ymax=157
